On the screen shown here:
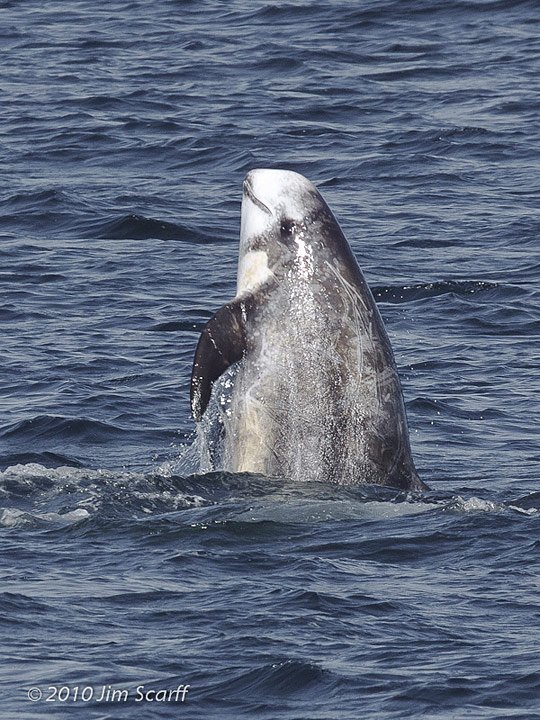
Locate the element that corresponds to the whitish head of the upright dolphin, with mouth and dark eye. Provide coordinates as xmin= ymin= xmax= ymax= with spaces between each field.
xmin=238 ymin=169 xmax=342 ymax=294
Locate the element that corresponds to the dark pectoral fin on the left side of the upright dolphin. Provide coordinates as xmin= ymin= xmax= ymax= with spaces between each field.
xmin=191 ymin=300 xmax=246 ymax=422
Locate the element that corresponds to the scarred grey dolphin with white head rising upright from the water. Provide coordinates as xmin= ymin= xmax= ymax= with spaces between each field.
xmin=191 ymin=170 xmax=426 ymax=490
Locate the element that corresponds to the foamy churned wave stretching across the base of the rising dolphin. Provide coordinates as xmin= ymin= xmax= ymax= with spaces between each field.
xmin=0 ymin=464 xmax=540 ymax=532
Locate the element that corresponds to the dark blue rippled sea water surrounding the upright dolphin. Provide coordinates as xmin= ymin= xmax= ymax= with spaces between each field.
xmin=0 ymin=0 xmax=540 ymax=720
